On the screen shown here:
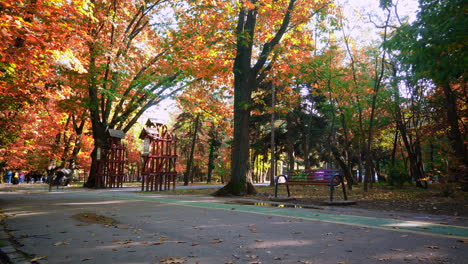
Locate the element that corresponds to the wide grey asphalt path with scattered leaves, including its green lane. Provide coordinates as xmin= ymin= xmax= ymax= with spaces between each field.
xmin=0 ymin=188 xmax=468 ymax=264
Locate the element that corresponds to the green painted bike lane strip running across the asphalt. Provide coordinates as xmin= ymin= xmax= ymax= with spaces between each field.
xmin=84 ymin=193 xmax=468 ymax=240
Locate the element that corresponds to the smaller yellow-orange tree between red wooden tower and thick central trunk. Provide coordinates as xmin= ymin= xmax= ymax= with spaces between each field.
xmin=174 ymin=81 xmax=232 ymax=185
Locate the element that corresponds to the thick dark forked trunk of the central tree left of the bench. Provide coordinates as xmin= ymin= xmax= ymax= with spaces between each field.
xmin=214 ymin=0 xmax=296 ymax=195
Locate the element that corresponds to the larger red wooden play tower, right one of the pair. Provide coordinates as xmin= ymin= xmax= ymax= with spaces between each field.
xmin=140 ymin=119 xmax=177 ymax=191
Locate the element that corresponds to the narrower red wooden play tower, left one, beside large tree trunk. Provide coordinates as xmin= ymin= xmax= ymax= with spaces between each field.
xmin=95 ymin=129 xmax=127 ymax=188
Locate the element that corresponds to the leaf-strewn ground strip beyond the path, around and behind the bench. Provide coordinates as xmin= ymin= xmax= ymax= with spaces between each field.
xmin=167 ymin=184 xmax=468 ymax=216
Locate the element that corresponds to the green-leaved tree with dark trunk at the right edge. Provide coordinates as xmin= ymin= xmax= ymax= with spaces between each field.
xmin=390 ymin=0 xmax=467 ymax=186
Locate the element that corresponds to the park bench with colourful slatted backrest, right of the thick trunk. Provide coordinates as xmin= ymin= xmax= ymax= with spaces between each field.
xmin=275 ymin=169 xmax=348 ymax=201
